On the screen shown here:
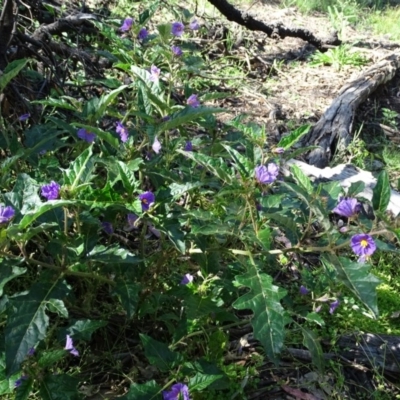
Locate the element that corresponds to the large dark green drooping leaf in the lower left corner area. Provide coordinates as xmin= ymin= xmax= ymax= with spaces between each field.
xmin=5 ymin=280 xmax=69 ymax=375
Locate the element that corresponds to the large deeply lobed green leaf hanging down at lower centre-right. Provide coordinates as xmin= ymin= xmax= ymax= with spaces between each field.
xmin=233 ymin=264 xmax=286 ymax=362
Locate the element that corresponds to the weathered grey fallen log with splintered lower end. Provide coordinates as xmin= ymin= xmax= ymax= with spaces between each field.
xmin=302 ymin=51 xmax=400 ymax=168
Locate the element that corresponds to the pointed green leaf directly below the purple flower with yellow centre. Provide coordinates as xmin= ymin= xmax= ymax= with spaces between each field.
xmin=322 ymin=254 xmax=380 ymax=317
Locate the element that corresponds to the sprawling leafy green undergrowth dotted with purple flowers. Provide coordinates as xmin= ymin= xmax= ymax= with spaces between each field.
xmin=0 ymin=1 xmax=400 ymax=400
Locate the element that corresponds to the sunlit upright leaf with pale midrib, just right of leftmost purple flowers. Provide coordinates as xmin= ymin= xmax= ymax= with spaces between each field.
xmin=63 ymin=146 xmax=95 ymax=193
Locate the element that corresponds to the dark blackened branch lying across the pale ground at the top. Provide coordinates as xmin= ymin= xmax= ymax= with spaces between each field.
xmin=208 ymin=0 xmax=341 ymax=51
